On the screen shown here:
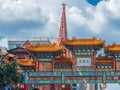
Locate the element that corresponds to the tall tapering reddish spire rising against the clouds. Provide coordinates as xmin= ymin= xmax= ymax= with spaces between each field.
xmin=59 ymin=3 xmax=68 ymax=40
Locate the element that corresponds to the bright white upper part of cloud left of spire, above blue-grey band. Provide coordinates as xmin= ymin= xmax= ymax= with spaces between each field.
xmin=0 ymin=0 xmax=49 ymax=23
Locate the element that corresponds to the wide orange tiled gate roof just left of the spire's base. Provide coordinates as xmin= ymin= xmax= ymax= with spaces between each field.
xmin=27 ymin=44 xmax=62 ymax=52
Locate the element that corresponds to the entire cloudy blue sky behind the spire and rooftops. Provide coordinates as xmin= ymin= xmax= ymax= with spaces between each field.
xmin=0 ymin=0 xmax=120 ymax=90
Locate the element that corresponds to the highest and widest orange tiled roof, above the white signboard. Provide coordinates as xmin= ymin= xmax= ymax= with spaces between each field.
xmin=64 ymin=37 xmax=105 ymax=46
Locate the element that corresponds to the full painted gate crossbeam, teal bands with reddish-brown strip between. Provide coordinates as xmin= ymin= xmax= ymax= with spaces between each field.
xmin=22 ymin=71 xmax=120 ymax=84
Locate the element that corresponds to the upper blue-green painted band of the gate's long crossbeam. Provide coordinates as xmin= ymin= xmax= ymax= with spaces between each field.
xmin=28 ymin=71 xmax=120 ymax=77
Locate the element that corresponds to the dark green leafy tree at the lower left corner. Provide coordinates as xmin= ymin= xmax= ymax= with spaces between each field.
xmin=0 ymin=62 xmax=20 ymax=87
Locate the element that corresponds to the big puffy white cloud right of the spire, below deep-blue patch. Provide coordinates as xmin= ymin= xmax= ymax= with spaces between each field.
xmin=68 ymin=0 xmax=120 ymax=35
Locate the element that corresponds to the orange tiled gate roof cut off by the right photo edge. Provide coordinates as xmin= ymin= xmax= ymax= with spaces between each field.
xmin=104 ymin=43 xmax=120 ymax=52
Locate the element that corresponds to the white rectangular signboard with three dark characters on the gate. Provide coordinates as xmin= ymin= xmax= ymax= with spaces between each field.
xmin=77 ymin=58 xmax=91 ymax=66
